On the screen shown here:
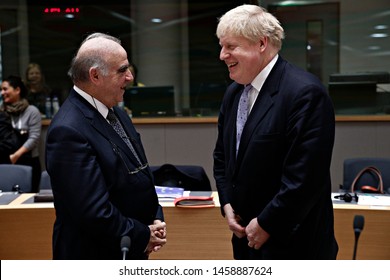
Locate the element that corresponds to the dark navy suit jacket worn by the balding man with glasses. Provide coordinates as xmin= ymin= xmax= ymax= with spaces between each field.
xmin=46 ymin=89 xmax=163 ymax=259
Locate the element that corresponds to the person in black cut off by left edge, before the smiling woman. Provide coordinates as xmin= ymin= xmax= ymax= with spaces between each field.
xmin=0 ymin=108 xmax=19 ymax=164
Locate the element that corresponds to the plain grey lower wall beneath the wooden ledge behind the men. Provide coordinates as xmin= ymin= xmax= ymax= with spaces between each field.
xmin=40 ymin=121 xmax=390 ymax=192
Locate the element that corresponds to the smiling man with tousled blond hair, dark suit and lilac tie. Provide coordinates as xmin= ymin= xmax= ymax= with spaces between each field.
xmin=214 ymin=5 xmax=338 ymax=259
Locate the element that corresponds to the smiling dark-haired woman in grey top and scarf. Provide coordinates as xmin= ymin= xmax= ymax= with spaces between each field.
xmin=1 ymin=76 xmax=42 ymax=192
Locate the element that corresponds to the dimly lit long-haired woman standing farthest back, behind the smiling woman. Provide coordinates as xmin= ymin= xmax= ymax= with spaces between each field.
xmin=25 ymin=63 xmax=52 ymax=115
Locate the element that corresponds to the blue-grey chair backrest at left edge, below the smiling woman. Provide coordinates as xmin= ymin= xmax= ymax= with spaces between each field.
xmin=0 ymin=164 xmax=32 ymax=192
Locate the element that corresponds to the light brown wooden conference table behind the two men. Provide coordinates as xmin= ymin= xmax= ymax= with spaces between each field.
xmin=0 ymin=192 xmax=390 ymax=260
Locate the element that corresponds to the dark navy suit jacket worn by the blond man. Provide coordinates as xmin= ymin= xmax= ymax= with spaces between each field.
xmin=214 ymin=57 xmax=338 ymax=259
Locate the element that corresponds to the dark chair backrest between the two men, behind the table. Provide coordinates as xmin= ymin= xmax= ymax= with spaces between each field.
xmin=150 ymin=163 xmax=211 ymax=191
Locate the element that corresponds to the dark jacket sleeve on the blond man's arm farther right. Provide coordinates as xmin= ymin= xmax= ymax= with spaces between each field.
xmin=258 ymin=84 xmax=335 ymax=237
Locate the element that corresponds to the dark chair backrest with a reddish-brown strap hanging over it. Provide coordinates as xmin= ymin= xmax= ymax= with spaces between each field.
xmin=342 ymin=157 xmax=390 ymax=194
